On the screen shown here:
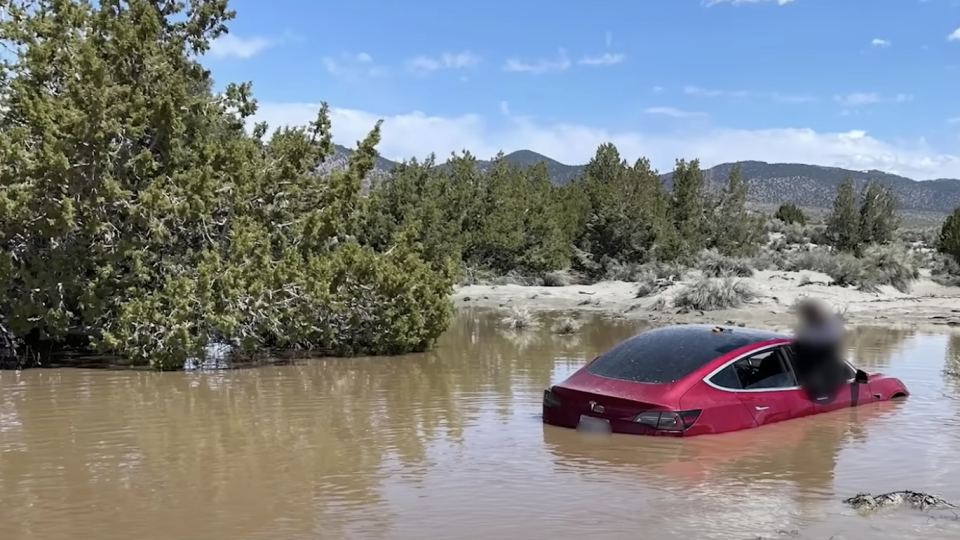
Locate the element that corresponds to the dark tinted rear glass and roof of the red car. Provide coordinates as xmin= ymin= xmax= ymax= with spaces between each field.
xmin=587 ymin=325 xmax=780 ymax=384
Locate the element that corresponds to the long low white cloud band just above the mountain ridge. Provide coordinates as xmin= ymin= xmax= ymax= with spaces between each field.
xmin=249 ymin=103 xmax=960 ymax=179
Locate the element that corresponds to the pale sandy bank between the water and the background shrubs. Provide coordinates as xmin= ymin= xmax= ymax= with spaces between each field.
xmin=453 ymin=271 xmax=960 ymax=329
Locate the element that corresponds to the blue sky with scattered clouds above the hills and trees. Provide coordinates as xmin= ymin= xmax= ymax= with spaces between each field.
xmin=205 ymin=0 xmax=960 ymax=179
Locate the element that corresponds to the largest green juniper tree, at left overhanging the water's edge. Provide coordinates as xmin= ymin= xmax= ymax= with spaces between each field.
xmin=0 ymin=0 xmax=452 ymax=368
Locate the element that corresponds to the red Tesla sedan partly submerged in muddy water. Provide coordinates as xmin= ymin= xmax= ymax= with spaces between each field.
xmin=543 ymin=325 xmax=910 ymax=437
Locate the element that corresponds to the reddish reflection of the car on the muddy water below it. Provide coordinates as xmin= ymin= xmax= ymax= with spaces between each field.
xmin=543 ymin=402 xmax=902 ymax=538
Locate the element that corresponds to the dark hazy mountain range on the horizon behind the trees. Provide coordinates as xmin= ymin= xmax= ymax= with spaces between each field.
xmin=323 ymin=145 xmax=960 ymax=214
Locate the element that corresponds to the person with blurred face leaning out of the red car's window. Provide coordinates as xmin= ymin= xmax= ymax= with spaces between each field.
xmin=793 ymin=299 xmax=848 ymax=401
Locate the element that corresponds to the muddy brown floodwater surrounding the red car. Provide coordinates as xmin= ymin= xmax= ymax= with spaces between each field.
xmin=0 ymin=314 xmax=960 ymax=540
